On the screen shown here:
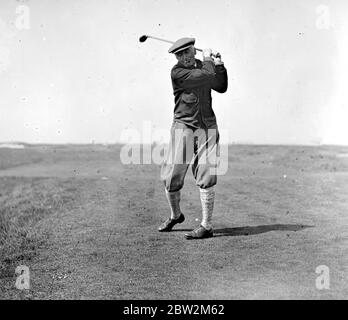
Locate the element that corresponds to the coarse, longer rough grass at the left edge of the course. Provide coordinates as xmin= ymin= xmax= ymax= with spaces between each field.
xmin=0 ymin=177 xmax=78 ymax=292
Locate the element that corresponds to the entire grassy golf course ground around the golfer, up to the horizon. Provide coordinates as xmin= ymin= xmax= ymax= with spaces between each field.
xmin=0 ymin=145 xmax=348 ymax=299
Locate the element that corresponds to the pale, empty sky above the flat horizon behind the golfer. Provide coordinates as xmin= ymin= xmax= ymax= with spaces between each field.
xmin=0 ymin=0 xmax=348 ymax=144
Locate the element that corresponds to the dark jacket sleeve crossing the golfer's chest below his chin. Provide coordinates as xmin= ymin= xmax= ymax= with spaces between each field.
xmin=171 ymin=59 xmax=215 ymax=89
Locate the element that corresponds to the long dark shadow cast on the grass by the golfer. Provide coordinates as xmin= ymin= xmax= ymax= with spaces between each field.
xmin=214 ymin=224 xmax=314 ymax=237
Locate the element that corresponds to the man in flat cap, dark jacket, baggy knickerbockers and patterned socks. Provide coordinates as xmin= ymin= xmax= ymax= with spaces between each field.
xmin=158 ymin=38 xmax=228 ymax=239
